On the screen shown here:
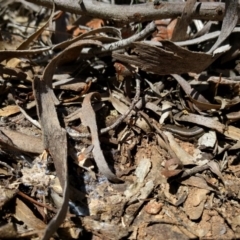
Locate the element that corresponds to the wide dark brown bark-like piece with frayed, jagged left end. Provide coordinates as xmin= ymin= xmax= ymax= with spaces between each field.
xmin=113 ymin=41 xmax=218 ymax=75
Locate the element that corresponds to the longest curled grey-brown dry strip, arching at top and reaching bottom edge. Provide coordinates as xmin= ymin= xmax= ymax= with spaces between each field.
xmin=33 ymin=40 xmax=99 ymax=240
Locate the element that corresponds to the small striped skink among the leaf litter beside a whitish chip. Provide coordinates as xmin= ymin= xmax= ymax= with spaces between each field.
xmin=162 ymin=124 xmax=204 ymax=140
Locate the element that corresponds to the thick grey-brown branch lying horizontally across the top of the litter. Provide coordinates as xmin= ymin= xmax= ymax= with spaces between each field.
xmin=25 ymin=0 xmax=228 ymax=23
